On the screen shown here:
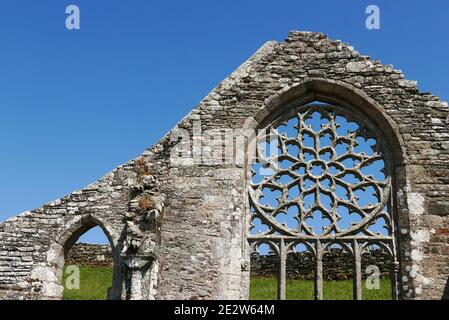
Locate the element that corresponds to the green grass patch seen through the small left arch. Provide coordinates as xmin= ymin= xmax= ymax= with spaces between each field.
xmin=62 ymin=266 xmax=112 ymax=300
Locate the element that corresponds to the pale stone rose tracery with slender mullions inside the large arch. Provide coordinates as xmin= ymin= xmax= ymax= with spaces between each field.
xmin=249 ymin=103 xmax=395 ymax=299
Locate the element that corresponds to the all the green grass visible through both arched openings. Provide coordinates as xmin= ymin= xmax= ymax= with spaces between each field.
xmin=63 ymin=266 xmax=391 ymax=300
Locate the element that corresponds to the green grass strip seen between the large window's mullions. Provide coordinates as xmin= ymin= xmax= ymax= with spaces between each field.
xmin=250 ymin=277 xmax=391 ymax=300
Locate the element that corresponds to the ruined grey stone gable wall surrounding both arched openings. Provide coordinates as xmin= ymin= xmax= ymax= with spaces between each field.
xmin=0 ymin=31 xmax=449 ymax=299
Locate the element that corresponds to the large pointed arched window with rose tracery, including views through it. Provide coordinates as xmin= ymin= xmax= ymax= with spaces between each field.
xmin=247 ymin=85 xmax=400 ymax=300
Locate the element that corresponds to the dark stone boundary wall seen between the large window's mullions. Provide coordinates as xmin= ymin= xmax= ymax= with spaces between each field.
xmin=251 ymin=250 xmax=391 ymax=280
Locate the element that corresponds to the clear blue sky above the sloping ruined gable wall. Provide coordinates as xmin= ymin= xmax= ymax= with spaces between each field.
xmin=0 ymin=0 xmax=449 ymax=244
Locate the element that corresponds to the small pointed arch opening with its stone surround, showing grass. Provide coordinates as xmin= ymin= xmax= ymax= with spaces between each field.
xmin=52 ymin=215 xmax=121 ymax=300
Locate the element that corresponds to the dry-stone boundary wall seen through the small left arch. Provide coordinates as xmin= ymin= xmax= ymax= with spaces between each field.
xmin=65 ymin=243 xmax=113 ymax=267
